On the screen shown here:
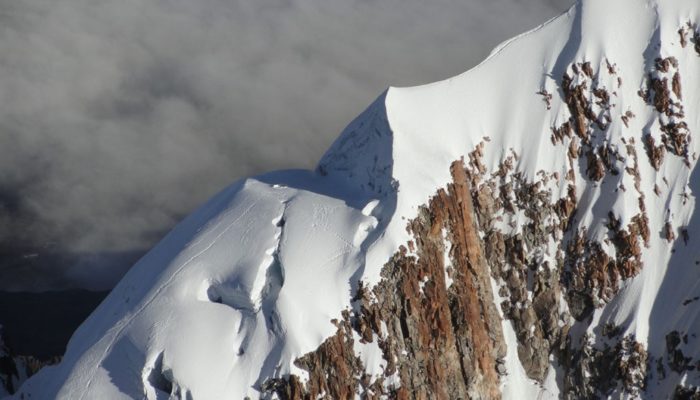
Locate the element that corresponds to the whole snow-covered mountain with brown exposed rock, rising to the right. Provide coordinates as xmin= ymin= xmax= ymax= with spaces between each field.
xmin=5 ymin=0 xmax=700 ymax=399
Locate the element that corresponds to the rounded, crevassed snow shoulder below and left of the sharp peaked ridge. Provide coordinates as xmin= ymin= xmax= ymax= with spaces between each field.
xmin=6 ymin=176 xmax=388 ymax=399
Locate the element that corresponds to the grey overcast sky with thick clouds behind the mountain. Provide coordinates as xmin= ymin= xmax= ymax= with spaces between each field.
xmin=0 ymin=0 xmax=573 ymax=289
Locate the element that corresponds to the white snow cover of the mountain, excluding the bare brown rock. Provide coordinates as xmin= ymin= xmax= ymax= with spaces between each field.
xmin=9 ymin=0 xmax=700 ymax=399
